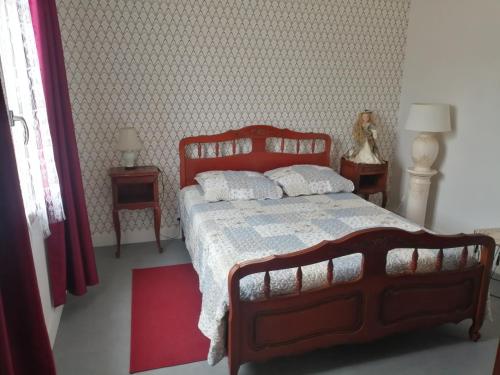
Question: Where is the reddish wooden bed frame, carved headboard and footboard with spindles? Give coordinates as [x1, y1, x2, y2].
[179, 125, 495, 375]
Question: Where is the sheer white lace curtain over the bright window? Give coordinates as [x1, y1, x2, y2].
[0, 0, 64, 236]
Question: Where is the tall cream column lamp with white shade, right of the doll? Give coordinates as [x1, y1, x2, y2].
[406, 103, 451, 226]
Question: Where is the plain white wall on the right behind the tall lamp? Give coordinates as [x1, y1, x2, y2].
[392, 0, 500, 232]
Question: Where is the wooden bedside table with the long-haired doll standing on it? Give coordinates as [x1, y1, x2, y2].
[340, 158, 388, 207]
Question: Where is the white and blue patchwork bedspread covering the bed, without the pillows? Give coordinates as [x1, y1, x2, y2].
[179, 186, 473, 365]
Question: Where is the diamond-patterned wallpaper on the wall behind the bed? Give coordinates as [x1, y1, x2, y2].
[57, 0, 410, 244]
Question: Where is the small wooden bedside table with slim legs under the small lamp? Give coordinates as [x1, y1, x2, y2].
[109, 166, 163, 258]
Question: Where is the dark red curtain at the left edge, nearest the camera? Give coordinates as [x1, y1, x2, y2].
[0, 81, 55, 375]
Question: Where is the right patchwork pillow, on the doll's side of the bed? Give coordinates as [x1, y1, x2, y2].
[264, 164, 354, 197]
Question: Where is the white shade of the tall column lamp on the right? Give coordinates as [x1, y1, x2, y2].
[406, 103, 451, 133]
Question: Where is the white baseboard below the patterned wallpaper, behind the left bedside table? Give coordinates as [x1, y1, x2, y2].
[92, 225, 181, 247]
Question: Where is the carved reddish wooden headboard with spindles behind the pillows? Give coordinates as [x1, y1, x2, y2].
[179, 125, 332, 188]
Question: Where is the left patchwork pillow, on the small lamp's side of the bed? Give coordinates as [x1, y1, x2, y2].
[195, 171, 283, 202]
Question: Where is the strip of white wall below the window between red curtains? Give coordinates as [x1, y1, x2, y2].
[29, 221, 63, 346]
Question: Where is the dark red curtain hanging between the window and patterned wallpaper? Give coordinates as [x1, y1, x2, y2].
[29, 0, 99, 306]
